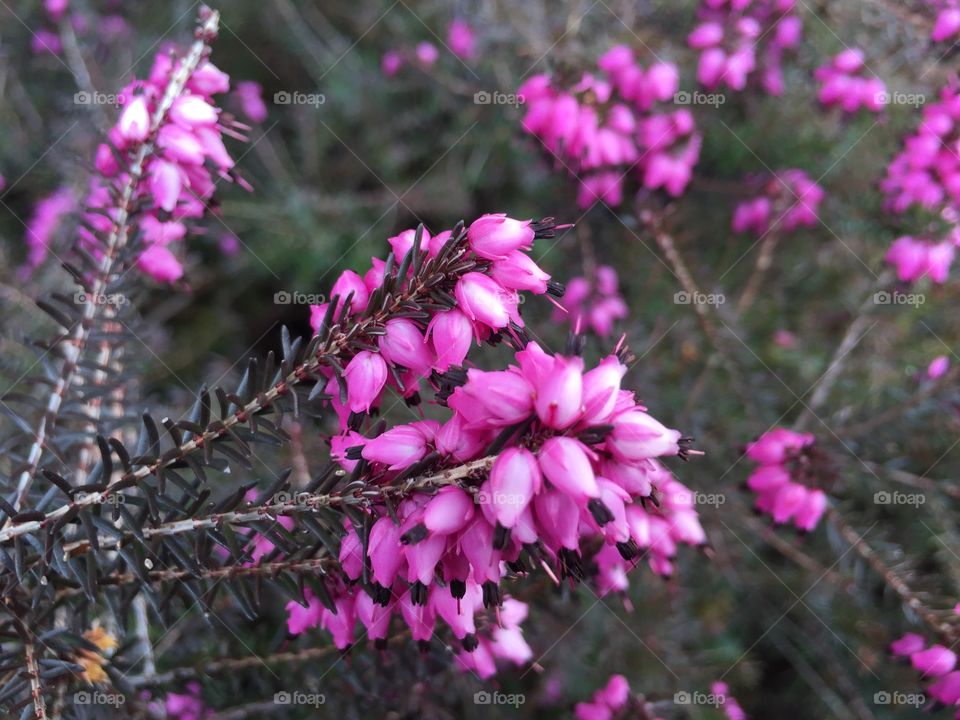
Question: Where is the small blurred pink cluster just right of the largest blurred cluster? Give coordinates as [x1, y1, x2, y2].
[731, 169, 826, 236]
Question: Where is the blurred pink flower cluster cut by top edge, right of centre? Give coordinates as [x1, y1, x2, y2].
[687, 0, 803, 95]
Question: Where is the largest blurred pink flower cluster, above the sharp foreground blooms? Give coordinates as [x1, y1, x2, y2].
[517, 45, 701, 208]
